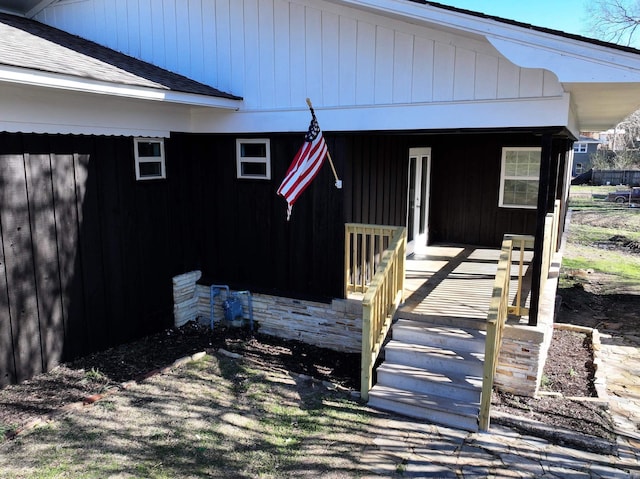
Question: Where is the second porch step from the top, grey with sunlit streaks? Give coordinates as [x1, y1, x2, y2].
[384, 339, 484, 377]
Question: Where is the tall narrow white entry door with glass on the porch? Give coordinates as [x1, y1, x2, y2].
[407, 148, 431, 255]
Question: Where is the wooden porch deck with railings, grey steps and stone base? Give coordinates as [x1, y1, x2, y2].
[345, 205, 559, 430]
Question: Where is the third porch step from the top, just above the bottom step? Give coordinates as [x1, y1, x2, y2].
[377, 362, 482, 403]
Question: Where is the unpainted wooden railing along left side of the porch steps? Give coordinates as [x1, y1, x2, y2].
[345, 223, 407, 401]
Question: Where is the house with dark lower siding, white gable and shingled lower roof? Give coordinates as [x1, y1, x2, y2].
[0, 0, 640, 390]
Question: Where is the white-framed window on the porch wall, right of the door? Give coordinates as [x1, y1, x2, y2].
[499, 147, 542, 208]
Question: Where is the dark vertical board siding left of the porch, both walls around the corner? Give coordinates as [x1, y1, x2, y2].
[0, 133, 344, 384]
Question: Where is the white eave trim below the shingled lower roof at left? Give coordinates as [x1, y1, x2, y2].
[0, 66, 242, 110]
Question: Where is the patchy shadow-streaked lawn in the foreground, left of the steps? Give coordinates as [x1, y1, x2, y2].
[0, 356, 371, 479]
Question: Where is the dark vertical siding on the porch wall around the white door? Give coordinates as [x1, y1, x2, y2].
[338, 131, 566, 247]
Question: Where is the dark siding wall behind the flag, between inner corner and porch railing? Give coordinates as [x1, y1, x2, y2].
[167, 134, 344, 300]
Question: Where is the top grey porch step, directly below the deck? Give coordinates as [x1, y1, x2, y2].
[393, 319, 487, 353]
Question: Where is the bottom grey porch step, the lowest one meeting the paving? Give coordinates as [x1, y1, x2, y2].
[369, 384, 480, 432]
